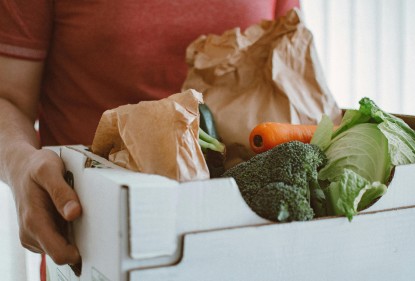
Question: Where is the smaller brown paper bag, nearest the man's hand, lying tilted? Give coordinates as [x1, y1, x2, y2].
[91, 90, 209, 182]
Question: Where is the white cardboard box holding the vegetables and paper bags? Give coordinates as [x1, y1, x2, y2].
[47, 146, 415, 281]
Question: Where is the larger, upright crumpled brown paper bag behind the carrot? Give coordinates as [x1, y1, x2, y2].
[183, 9, 341, 167]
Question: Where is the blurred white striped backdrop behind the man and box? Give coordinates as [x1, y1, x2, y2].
[0, 0, 415, 281]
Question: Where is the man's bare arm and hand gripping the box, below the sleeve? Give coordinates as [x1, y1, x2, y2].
[0, 55, 81, 264]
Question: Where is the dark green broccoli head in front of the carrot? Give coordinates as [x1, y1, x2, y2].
[223, 141, 327, 221]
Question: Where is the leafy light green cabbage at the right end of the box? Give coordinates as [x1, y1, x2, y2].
[311, 98, 415, 220]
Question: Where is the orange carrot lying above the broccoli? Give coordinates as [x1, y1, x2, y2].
[249, 122, 317, 153]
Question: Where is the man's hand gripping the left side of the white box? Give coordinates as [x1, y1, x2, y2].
[12, 149, 81, 265]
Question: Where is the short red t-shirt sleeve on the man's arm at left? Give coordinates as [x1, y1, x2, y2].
[0, 0, 53, 60]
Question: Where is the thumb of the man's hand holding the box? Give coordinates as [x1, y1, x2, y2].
[32, 151, 82, 221]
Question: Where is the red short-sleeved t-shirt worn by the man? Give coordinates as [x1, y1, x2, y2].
[0, 0, 299, 145]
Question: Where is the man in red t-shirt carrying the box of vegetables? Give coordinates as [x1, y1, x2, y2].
[0, 0, 299, 276]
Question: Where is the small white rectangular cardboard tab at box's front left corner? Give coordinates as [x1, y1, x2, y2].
[128, 174, 179, 259]
